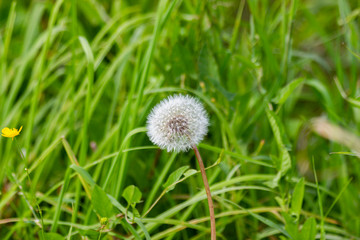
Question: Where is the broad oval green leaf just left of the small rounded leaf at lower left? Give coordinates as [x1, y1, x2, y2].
[91, 185, 114, 218]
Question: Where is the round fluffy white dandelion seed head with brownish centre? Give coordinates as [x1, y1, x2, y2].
[147, 95, 209, 152]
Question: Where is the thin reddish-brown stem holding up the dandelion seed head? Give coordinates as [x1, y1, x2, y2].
[193, 145, 216, 240]
